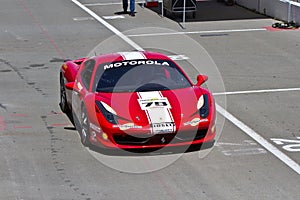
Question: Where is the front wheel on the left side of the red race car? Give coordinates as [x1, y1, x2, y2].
[80, 106, 90, 147]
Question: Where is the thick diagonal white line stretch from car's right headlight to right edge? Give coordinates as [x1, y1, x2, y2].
[216, 104, 300, 174]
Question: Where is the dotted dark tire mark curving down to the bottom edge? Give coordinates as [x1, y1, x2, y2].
[41, 116, 91, 200]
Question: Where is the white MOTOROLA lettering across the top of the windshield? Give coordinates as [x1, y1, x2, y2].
[103, 60, 169, 70]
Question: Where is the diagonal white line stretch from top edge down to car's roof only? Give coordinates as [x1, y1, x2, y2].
[71, 0, 143, 51]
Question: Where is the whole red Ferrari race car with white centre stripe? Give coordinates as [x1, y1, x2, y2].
[60, 51, 216, 149]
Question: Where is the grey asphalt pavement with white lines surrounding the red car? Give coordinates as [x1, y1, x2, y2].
[0, 0, 300, 200]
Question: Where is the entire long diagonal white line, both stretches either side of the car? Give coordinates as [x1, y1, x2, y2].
[71, 0, 300, 174]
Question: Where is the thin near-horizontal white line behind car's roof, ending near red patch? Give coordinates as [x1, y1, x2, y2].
[127, 28, 267, 37]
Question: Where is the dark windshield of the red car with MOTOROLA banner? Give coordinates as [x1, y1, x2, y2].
[94, 60, 191, 92]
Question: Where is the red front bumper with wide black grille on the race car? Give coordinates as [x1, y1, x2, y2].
[91, 122, 216, 149]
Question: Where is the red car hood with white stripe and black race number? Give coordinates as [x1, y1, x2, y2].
[96, 87, 202, 126]
